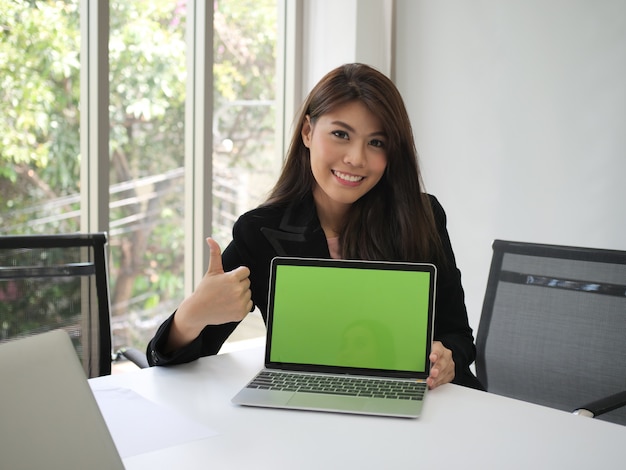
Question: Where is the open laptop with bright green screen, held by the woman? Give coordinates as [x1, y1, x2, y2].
[232, 257, 436, 418]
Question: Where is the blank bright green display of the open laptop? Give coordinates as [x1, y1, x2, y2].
[270, 265, 431, 372]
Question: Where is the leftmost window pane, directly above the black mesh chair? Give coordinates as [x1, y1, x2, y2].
[0, 0, 80, 234]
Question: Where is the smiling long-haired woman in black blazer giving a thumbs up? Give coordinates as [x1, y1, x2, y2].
[148, 64, 481, 388]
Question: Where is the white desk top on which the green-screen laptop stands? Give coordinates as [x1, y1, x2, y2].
[90, 347, 626, 470]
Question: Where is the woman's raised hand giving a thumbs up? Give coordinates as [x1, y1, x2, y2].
[168, 238, 253, 350]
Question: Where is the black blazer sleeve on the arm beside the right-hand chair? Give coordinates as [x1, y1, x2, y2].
[430, 196, 482, 389]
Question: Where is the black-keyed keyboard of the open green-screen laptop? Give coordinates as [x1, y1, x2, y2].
[248, 371, 426, 400]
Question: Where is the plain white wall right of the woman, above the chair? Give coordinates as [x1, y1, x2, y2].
[394, 0, 626, 329]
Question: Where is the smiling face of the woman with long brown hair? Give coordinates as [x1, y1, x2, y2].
[302, 101, 388, 212]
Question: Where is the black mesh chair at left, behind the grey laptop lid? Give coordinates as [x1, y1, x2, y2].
[0, 233, 112, 377]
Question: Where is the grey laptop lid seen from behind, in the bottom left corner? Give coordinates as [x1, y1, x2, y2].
[0, 330, 124, 470]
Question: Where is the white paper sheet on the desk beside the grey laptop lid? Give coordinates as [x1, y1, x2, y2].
[93, 388, 218, 458]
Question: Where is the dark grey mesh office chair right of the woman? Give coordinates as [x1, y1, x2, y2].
[476, 240, 626, 425]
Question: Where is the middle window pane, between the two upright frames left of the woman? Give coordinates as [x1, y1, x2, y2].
[108, 0, 188, 349]
